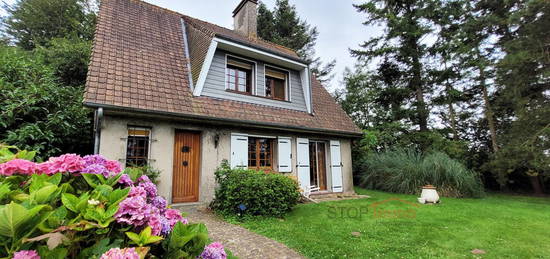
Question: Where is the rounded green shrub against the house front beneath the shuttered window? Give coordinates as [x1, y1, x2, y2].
[211, 161, 300, 217]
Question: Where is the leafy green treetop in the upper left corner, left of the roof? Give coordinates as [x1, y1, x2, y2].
[4, 0, 96, 50]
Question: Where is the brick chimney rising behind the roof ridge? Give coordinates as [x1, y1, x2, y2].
[233, 0, 258, 38]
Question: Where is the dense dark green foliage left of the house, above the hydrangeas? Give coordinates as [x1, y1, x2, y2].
[0, 47, 91, 157]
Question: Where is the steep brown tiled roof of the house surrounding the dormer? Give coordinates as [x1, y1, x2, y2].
[84, 0, 360, 135]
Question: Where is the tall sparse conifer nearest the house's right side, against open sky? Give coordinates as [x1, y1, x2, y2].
[351, 0, 435, 131]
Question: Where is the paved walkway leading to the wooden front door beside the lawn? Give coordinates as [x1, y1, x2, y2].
[181, 208, 305, 259]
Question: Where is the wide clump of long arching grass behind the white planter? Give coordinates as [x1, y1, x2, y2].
[358, 149, 484, 197]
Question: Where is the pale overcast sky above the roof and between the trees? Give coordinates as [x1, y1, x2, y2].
[146, 0, 376, 89]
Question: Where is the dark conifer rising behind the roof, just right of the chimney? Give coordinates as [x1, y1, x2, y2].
[258, 0, 336, 83]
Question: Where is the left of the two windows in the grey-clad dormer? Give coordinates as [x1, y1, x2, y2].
[225, 56, 254, 94]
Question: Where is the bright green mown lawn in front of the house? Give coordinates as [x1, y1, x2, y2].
[235, 189, 550, 258]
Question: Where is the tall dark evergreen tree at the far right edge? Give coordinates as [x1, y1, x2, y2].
[479, 0, 550, 194]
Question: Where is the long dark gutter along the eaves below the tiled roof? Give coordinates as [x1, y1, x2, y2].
[84, 102, 363, 138]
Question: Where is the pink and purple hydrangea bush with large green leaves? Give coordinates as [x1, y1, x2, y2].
[0, 145, 228, 259]
